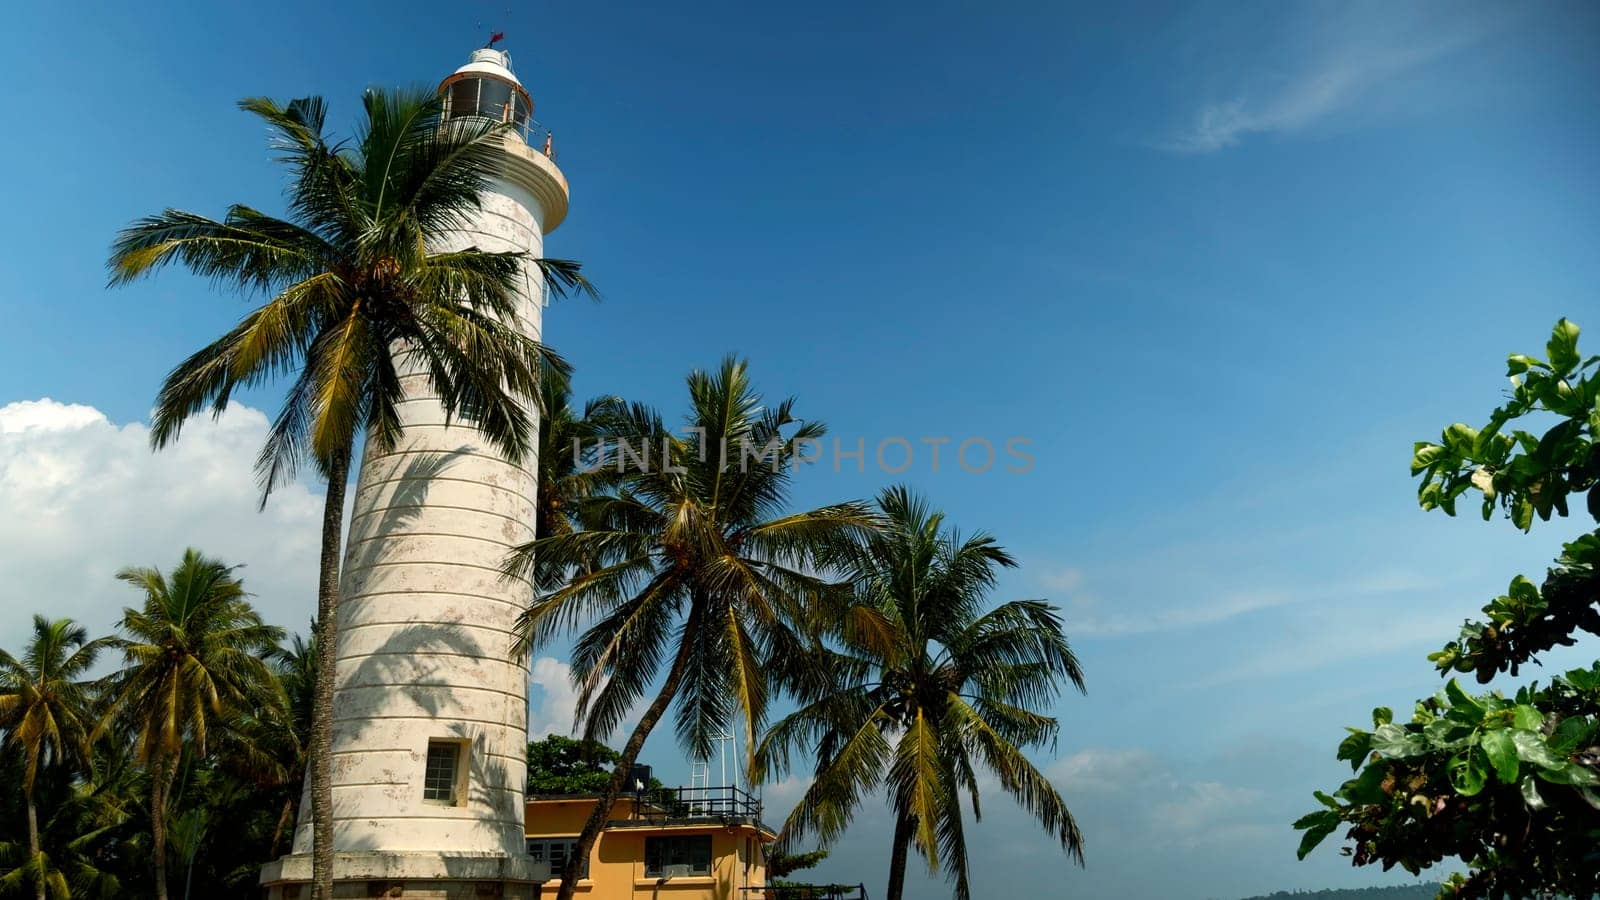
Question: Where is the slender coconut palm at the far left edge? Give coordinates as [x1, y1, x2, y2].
[0, 615, 106, 900]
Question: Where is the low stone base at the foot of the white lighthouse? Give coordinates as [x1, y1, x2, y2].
[261, 852, 550, 900]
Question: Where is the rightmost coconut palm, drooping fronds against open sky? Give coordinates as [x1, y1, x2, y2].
[757, 487, 1083, 900]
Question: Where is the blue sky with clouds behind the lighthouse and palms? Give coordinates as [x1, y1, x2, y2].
[0, 3, 1600, 900]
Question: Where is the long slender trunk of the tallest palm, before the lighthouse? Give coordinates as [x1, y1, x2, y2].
[309, 448, 350, 900]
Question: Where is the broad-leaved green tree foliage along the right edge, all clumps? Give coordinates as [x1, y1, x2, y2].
[1294, 319, 1600, 900]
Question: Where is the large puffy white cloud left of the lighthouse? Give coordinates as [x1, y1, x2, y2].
[0, 399, 322, 649]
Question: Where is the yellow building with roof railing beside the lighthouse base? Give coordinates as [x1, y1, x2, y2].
[523, 788, 778, 900]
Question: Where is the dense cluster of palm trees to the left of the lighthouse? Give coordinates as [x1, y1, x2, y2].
[0, 549, 315, 900]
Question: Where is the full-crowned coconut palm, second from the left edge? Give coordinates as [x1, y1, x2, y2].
[106, 548, 283, 900]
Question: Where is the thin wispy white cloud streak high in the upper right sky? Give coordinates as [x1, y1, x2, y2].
[1162, 5, 1499, 154]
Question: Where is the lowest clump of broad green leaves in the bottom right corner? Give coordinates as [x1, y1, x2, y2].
[1294, 663, 1600, 897]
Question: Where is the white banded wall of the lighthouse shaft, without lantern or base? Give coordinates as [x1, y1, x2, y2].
[294, 173, 544, 857]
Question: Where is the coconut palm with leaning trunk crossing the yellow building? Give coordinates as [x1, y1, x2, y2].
[507, 357, 874, 900]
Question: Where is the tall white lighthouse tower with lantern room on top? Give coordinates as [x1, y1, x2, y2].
[261, 50, 568, 900]
